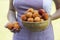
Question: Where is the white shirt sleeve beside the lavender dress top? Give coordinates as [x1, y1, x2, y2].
[43, 0, 52, 14]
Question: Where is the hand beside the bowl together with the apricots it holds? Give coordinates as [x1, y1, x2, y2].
[6, 22, 21, 32]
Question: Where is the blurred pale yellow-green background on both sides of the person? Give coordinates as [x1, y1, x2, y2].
[0, 0, 60, 40]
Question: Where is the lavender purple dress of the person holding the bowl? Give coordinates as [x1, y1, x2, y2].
[13, 0, 54, 40]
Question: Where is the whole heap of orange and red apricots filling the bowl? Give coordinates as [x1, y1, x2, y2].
[21, 8, 48, 22]
